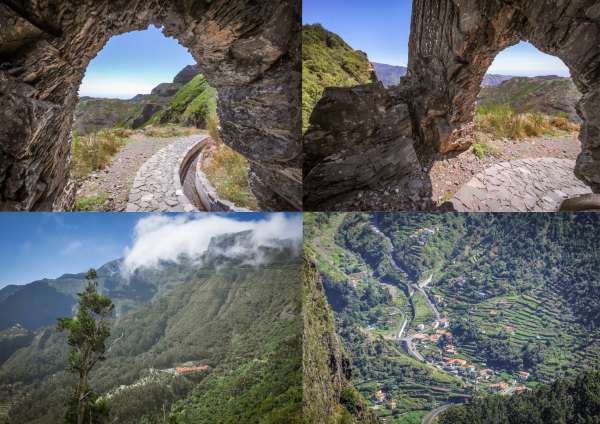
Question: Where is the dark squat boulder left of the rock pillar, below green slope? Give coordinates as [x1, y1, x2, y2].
[303, 83, 431, 210]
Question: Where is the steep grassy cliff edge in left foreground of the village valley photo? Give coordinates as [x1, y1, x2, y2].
[303, 255, 378, 424]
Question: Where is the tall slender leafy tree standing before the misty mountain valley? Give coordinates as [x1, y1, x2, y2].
[57, 269, 114, 424]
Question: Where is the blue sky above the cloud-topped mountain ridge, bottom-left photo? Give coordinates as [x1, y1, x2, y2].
[0, 212, 301, 288]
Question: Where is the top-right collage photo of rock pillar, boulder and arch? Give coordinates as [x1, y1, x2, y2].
[302, 0, 600, 212]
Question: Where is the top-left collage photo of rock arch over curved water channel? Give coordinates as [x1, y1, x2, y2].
[0, 0, 302, 212]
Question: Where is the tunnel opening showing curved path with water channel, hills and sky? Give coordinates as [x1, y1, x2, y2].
[71, 26, 257, 211]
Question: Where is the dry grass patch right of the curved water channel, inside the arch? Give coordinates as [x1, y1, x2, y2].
[204, 114, 258, 210]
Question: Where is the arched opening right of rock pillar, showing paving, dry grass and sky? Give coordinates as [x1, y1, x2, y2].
[429, 41, 591, 212]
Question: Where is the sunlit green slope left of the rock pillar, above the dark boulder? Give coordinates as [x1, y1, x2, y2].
[302, 24, 377, 129]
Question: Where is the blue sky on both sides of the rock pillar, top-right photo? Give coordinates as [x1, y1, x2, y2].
[302, 0, 569, 76]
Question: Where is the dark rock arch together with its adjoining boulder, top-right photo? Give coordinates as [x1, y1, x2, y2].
[303, 0, 600, 210]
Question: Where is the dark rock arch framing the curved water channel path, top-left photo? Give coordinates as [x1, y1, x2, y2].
[0, 0, 302, 210]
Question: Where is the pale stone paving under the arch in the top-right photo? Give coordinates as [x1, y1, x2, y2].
[451, 158, 591, 212]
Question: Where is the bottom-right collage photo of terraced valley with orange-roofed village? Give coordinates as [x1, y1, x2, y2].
[303, 212, 600, 424]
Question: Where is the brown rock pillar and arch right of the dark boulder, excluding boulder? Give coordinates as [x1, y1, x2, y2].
[406, 0, 600, 192]
